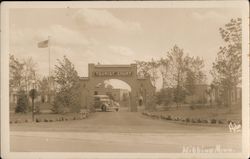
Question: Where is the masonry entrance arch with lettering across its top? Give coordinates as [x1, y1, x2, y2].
[80, 64, 155, 112]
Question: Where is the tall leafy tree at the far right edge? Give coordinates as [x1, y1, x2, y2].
[211, 18, 242, 107]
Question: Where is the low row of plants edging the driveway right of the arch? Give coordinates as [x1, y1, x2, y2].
[142, 112, 241, 124]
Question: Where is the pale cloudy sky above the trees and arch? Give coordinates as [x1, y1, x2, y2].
[9, 8, 240, 87]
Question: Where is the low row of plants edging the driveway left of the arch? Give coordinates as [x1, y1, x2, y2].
[10, 112, 90, 124]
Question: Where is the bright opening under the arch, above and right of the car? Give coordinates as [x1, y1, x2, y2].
[94, 79, 131, 111]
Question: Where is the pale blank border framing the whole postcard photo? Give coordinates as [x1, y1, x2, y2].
[1, 1, 249, 159]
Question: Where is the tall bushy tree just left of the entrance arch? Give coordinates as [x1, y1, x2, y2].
[52, 56, 81, 113]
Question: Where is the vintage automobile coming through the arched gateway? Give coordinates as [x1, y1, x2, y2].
[94, 95, 119, 112]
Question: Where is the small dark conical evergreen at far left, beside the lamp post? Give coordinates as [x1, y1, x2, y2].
[15, 90, 28, 113]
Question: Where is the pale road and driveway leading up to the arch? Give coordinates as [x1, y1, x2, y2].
[10, 108, 241, 152]
